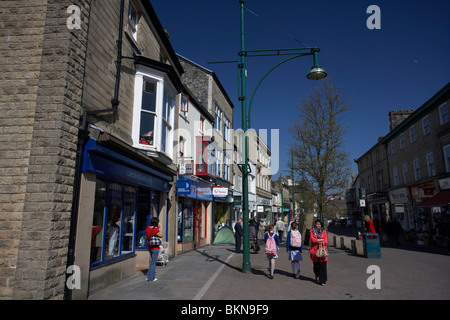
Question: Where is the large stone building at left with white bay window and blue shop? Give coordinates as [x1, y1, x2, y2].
[0, 0, 213, 299]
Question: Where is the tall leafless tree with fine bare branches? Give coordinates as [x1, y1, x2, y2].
[288, 80, 350, 218]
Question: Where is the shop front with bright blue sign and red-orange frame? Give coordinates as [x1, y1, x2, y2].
[176, 175, 213, 253]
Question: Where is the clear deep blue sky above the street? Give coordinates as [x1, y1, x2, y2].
[151, 0, 450, 182]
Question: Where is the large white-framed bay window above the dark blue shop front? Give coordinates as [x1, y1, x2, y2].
[132, 68, 177, 158]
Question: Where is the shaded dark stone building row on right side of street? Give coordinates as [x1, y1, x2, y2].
[355, 84, 450, 244]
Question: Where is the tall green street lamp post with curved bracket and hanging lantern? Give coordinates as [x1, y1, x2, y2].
[238, 0, 327, 273]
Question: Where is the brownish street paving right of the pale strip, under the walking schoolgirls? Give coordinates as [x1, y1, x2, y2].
[203, 242, 450, 300]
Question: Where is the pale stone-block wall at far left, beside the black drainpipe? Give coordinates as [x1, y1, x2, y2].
[0, 0, 89, 299]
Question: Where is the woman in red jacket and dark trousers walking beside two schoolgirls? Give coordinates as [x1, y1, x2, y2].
[309, 220, 328, 286]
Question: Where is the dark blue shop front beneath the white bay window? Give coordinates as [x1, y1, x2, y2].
[75, 139, 172, 295]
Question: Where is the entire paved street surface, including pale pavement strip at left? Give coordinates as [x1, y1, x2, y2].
[89, 232, 450, 302]
